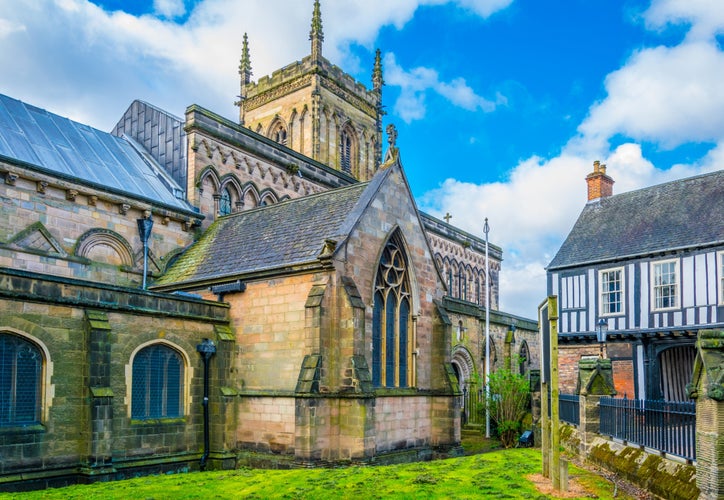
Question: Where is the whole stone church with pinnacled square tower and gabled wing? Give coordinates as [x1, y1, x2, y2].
[0, 1, 539, 490]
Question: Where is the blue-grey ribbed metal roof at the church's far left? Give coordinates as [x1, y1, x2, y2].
[0, 94, 191, 211]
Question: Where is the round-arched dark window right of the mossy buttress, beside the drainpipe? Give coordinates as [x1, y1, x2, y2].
[131, 344, 184, 419]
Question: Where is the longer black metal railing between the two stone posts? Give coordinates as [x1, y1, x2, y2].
[600, 397, 696, 461]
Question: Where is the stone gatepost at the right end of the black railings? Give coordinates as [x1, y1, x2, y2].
[689, 330, 724, 500]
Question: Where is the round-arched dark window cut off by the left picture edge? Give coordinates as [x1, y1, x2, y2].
[0, 333, 43, 427]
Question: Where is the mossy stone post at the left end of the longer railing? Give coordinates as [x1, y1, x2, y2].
[577, 356, 616, 456]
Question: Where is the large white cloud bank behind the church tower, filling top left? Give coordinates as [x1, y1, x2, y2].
[0, 0, 510, 130]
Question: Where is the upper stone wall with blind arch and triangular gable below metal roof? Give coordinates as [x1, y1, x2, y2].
[0, 165, 194, 285]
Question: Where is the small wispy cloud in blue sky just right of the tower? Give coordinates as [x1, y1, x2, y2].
[384, 52, 506, 123]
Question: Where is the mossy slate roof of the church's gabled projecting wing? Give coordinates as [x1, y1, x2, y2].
[154, 173, 378, 289]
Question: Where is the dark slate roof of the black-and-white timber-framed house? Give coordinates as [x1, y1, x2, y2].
[547, 170, 724, 271]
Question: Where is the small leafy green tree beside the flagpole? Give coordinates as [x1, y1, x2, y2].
[486, 362, 530, 448]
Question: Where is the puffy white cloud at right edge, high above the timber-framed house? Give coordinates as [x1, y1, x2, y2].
[579, 42, 724, 148]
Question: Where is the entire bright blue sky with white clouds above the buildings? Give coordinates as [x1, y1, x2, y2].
[0, 0, 724, 317]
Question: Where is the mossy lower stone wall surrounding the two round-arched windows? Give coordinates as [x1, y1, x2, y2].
[0, 269, 228, 489]
